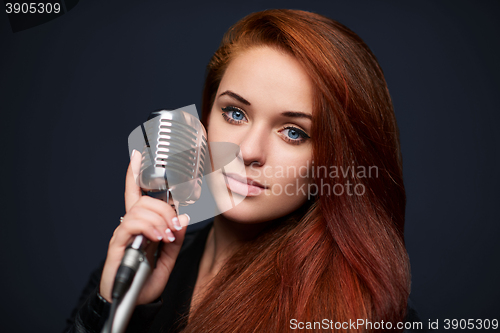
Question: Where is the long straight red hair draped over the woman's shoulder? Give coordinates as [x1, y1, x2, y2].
[184, 10, 410, 333]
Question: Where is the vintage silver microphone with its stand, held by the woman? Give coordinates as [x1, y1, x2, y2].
[102, 105, 209, 333]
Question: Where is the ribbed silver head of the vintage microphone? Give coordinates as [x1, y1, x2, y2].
[138, 106, 208, 206]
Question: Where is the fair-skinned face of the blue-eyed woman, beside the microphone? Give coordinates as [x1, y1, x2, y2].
[208, 47, 313, 223]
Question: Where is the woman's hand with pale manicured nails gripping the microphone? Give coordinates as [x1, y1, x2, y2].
[99, 150, 189, 304]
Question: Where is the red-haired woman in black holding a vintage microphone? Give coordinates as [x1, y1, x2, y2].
[68, 10, 416, 332]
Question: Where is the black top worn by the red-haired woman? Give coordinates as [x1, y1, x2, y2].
[64, 221, 425, 333]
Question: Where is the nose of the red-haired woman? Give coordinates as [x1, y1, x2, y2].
[240, 124, 269, 166]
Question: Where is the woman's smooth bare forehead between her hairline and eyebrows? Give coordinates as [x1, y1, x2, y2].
[218, 47, 313, 113]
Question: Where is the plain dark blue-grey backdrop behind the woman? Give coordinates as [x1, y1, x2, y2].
[0, 0, 500, 332]
